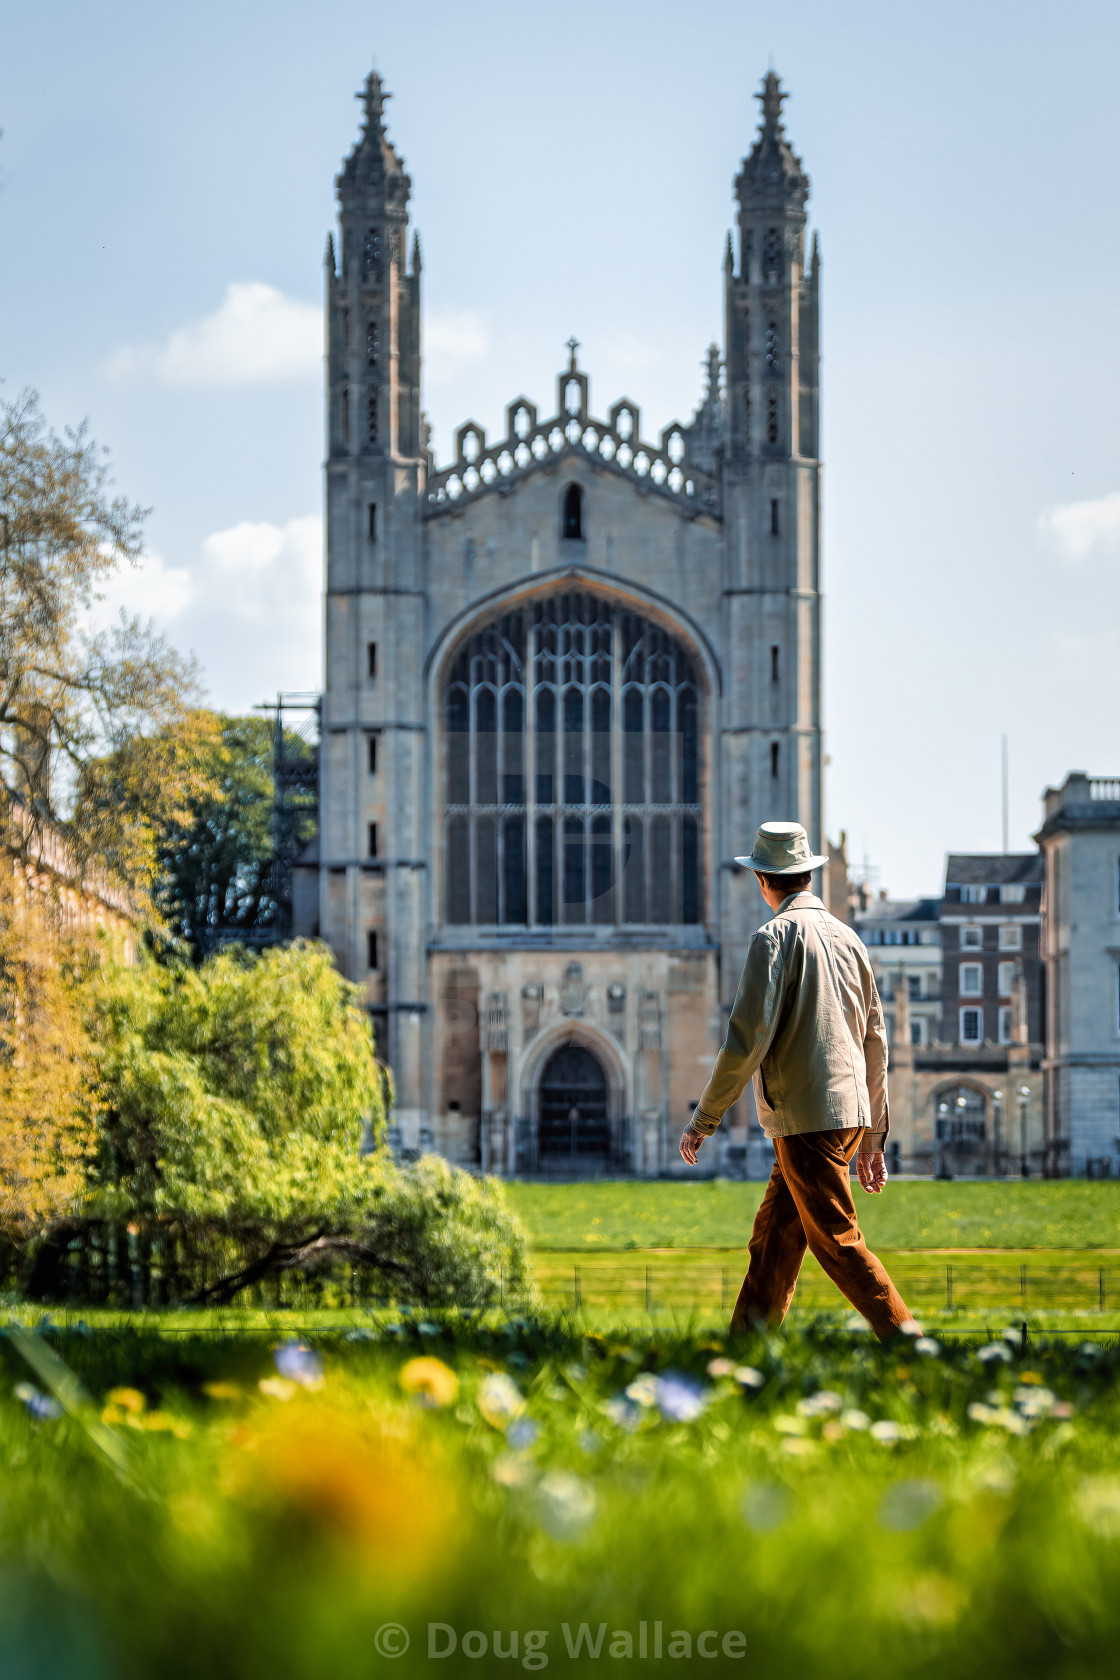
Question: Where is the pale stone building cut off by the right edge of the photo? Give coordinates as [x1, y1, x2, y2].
[1036, 771, 1120, 1176]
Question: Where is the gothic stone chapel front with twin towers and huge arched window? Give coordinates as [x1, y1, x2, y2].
[317, 74, 821, 1174]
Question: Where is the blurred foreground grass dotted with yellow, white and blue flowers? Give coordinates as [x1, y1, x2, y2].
[0, 1310, 1120, 1680]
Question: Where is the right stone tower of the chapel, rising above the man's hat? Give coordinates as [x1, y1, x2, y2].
[724, 71, 824, 974]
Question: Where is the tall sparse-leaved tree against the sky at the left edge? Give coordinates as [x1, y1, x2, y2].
[0, 393, 196, 895]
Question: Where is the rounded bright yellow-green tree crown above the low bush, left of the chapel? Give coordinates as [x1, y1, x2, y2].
[92, 946, 385, 1242]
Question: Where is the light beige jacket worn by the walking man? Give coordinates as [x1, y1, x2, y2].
[692, 892, 890, 1154]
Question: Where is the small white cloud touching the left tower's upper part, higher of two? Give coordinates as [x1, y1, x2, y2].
[106, 281, 322, 385]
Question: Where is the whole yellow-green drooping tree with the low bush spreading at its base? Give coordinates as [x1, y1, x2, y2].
[29, 944, 531, 1307]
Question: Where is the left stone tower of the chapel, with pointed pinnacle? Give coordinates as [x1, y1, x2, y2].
[319, 72, 427, 1142]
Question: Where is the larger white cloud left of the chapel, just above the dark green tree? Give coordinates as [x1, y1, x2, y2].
[96, 514, 322, 711]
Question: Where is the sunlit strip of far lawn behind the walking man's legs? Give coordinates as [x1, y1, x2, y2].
[507, 1179, 1120, 1250]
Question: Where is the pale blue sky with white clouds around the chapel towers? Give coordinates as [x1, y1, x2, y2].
[0, 0, 1120, 894]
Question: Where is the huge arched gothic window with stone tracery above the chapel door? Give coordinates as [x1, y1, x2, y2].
[443, 593, 702, 927]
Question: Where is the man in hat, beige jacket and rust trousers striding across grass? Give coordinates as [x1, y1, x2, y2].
[680, 823, 910, 1342]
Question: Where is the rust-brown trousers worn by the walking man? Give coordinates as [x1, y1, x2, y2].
[730, 1126, 910, 1342]
